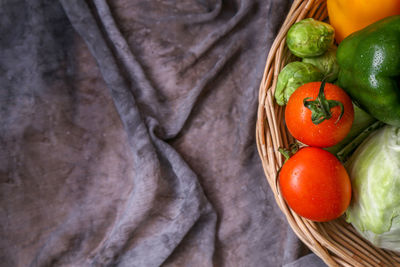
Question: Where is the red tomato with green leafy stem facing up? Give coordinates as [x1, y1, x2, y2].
[285, 82, 354, 147]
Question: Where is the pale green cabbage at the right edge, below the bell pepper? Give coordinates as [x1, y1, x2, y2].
[346, 125, 400, 251]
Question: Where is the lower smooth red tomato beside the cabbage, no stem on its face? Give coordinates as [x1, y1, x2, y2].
[279, 147, 351, 222]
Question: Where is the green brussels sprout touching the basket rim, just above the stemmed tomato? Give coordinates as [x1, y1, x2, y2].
[275, 61, 324, 106]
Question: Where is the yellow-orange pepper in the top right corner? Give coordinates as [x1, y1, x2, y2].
[327, 0, 400, 43]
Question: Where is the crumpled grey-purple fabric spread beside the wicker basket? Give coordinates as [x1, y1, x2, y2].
[0, 0, 324, 266]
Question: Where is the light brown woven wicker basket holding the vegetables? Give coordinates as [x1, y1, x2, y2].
[256, 0, 400, 267]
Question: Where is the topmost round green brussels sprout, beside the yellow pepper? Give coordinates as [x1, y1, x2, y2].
[286, 18, 335, 58]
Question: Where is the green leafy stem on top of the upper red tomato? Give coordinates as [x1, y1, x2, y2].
[303, 80, 344, 125]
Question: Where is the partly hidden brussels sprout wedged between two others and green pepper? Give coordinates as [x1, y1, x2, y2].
[303, 45, 339, 82]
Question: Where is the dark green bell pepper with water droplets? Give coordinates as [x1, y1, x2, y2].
[337, 15, 400, 126]
